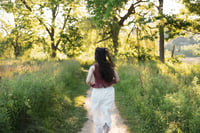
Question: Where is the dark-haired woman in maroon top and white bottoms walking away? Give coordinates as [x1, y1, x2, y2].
[86, 47, 119, 133]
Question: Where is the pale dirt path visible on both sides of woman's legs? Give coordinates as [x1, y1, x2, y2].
[79, 89, 129, 133]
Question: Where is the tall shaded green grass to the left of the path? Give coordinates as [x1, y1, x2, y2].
[0, 60, 87, 133]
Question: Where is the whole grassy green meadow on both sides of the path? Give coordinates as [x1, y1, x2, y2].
[0, 57, 200, 133]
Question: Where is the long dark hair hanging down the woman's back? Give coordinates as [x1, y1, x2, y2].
[95, 47, 115, 82]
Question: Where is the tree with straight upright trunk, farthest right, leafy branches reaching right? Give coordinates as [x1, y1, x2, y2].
[140, 0, 191, 63]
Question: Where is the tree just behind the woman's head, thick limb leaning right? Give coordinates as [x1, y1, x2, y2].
[87, 0, 149, 54]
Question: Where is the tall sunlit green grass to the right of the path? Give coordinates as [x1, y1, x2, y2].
[115, 62, 200, 133]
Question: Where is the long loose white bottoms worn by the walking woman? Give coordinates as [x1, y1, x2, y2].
[91, 86, 115, 128]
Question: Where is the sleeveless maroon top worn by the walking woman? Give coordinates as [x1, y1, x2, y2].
[91, 64, 116, 88]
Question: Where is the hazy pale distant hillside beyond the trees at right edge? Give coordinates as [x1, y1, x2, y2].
[165, 35, 200, 57]
